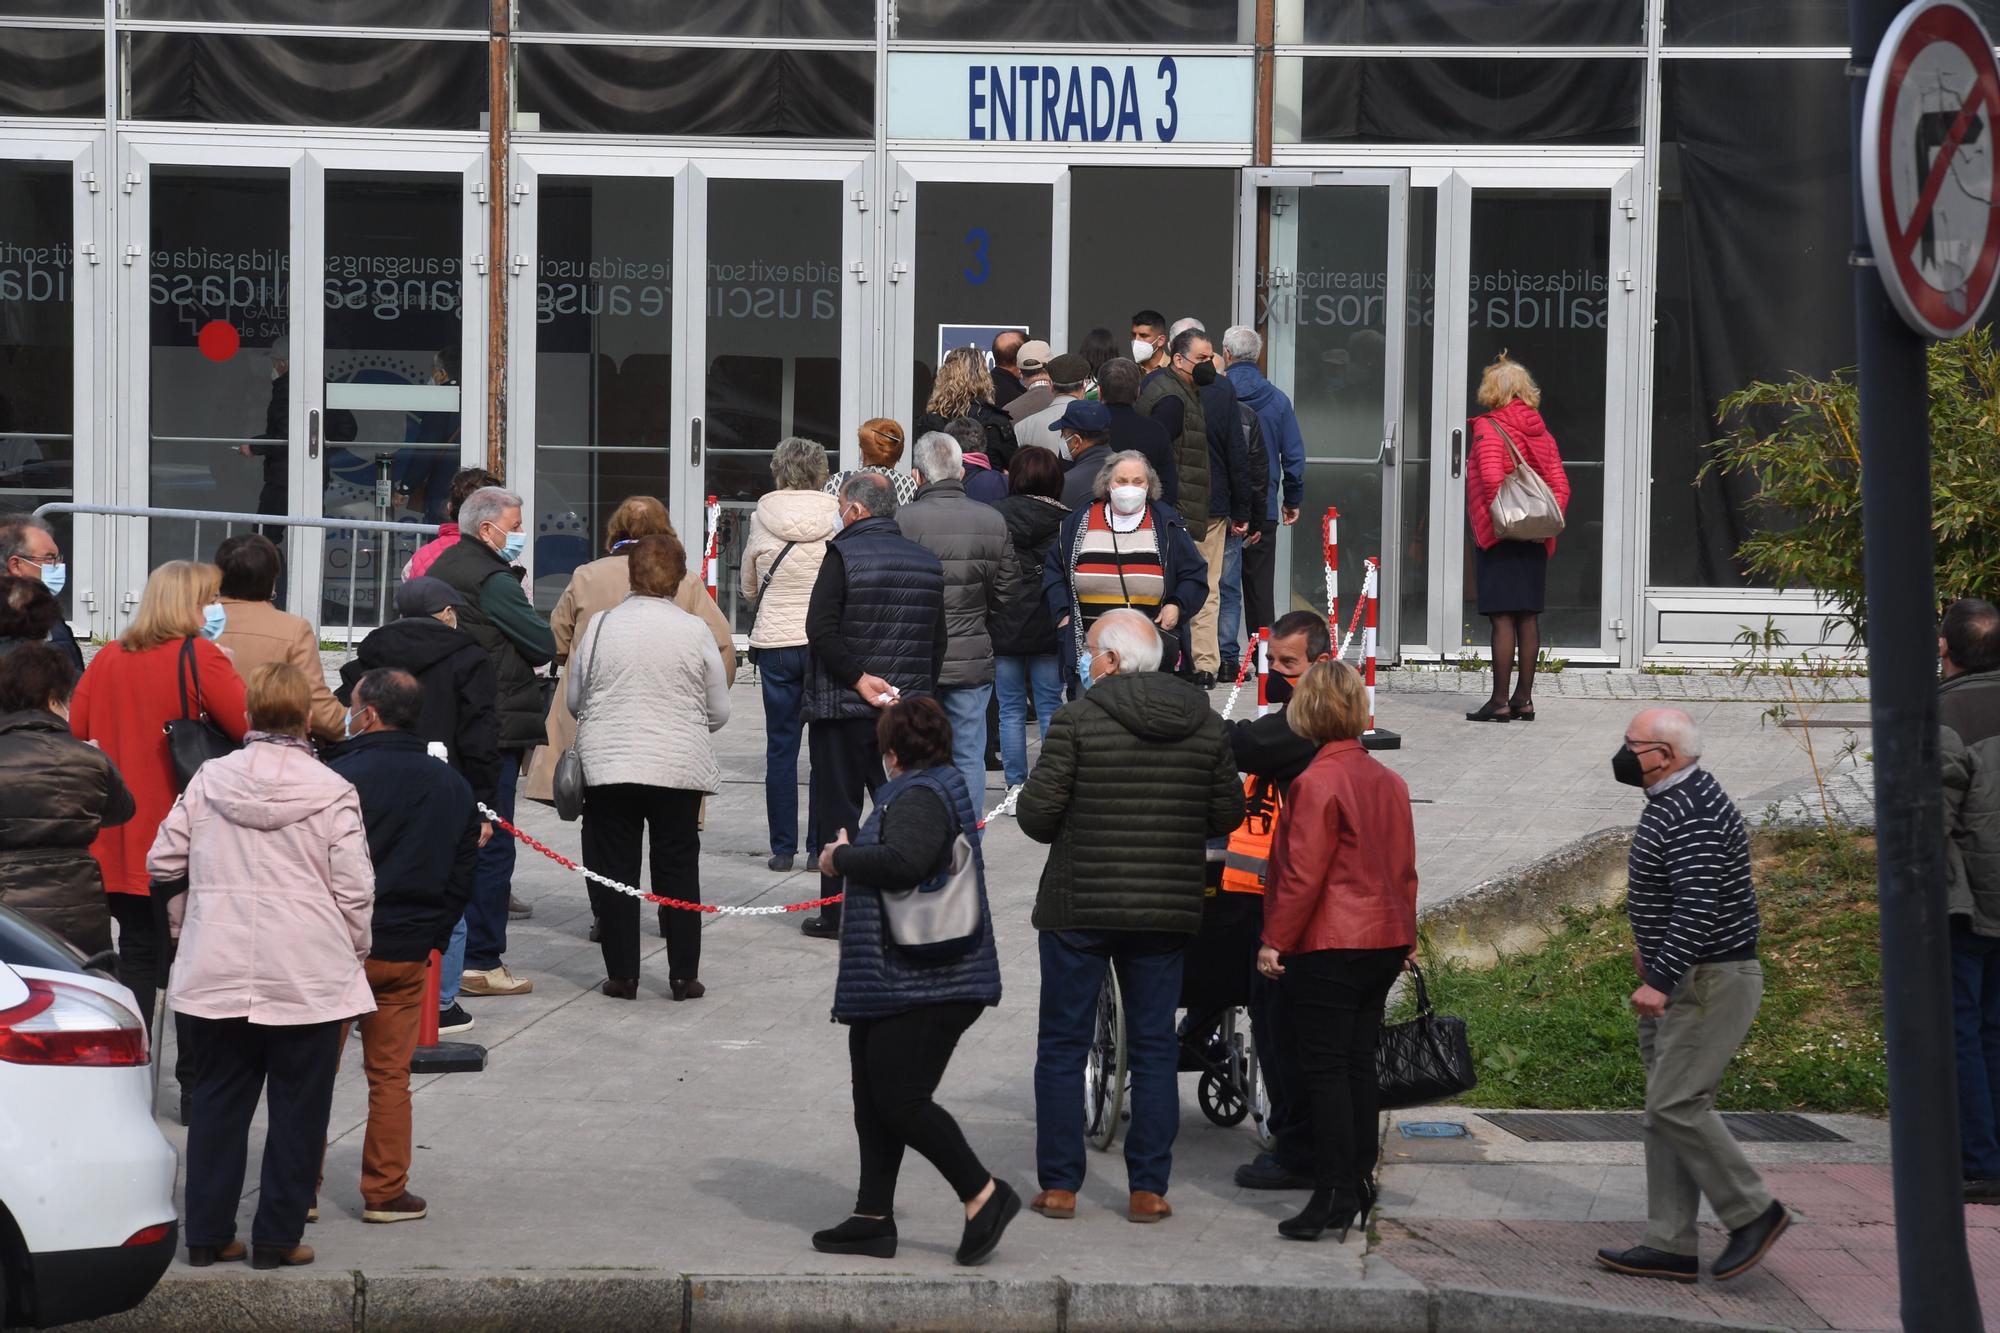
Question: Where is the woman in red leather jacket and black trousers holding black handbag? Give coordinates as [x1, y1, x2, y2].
[1256, 662, 1416, 1241]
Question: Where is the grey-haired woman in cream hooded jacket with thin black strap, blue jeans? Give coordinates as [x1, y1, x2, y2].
[742, 436, 840, 871]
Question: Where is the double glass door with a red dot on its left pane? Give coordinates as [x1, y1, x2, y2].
[120, 140, 486, 634]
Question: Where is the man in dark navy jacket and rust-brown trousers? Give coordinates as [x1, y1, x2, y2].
[332, 671, 480, 1223]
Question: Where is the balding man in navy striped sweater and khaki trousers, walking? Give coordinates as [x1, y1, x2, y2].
[1598, 709, 1790, 1283]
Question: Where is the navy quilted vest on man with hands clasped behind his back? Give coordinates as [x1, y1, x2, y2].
[804, 518, 944, 723]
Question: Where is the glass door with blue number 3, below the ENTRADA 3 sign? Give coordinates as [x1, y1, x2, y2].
[888, 162, 1070, 426]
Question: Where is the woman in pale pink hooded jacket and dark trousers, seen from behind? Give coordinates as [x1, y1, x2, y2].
[146, 662, 374, 1269]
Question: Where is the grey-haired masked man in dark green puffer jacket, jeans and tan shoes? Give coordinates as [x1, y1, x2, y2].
[428, 486, 556, 995]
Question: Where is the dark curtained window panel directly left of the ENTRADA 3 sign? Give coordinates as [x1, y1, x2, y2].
[516, 44, 874, 138]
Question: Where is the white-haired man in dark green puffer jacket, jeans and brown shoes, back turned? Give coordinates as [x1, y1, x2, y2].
[1014, 608, 1244, 1223]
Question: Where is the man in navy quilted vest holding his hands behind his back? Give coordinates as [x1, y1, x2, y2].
[800, 472, 948, 939]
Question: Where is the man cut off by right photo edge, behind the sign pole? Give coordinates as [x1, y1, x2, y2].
[1938, 598, 2000, 1203]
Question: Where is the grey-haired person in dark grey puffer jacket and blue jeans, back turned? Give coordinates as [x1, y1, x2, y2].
[900, 430, 1008, 827]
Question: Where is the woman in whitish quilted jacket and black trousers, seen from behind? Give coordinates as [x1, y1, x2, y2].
[568, 536, 730, 1001]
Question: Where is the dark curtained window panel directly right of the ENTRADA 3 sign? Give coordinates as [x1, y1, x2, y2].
[1302, 56, 1646, 144]
